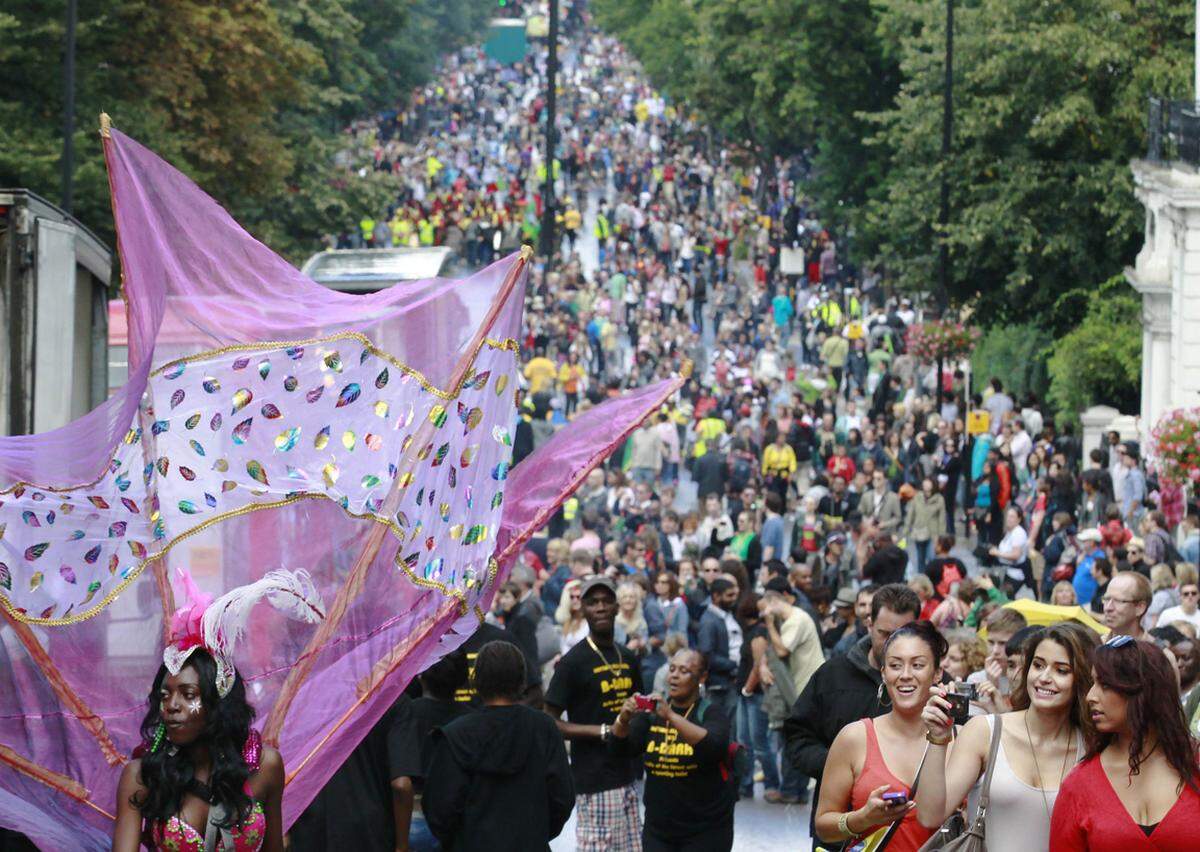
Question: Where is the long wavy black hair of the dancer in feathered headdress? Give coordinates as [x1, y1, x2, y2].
[130, 650, 254, 828]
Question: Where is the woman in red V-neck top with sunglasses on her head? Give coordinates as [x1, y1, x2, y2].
[1050, 636, 1200, 852]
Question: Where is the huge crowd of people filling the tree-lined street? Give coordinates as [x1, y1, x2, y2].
[296, 1, 1200, 852]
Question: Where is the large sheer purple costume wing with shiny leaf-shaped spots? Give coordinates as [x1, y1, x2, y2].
[0, 118, 682, 850]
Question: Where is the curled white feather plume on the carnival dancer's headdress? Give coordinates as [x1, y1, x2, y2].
[204, 570, 325, 659]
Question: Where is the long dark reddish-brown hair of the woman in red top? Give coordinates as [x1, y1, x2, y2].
[1087, 641, 1200, 792]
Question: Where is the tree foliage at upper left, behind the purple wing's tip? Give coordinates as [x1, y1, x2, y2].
[0, 0, 492, 260]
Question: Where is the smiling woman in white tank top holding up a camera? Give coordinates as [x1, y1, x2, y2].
[917, 622, 1098, 852]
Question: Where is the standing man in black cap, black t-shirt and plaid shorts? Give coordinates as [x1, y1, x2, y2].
[546, 576, 642, 852]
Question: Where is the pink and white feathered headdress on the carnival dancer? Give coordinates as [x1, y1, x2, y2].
[162, 569, 325, 698]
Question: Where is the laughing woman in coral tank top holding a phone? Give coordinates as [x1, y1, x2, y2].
[815, 622, 947, 852]
